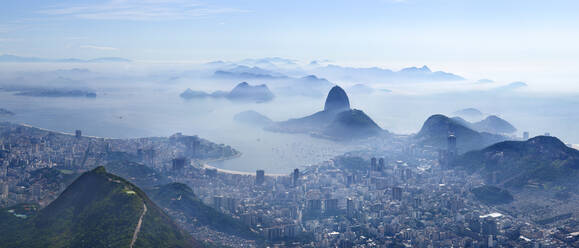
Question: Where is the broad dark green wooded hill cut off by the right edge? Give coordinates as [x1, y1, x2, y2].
[454, 136, 579, 187]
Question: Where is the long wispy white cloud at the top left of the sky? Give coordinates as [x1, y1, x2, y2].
[38, 0, 247, 21]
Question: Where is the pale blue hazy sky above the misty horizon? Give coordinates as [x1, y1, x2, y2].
[0, 0, 579, 82]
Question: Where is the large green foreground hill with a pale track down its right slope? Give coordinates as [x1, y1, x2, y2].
[0, 167, 200, 247]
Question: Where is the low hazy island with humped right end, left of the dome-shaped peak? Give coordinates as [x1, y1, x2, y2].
[179, 82, 274, 103]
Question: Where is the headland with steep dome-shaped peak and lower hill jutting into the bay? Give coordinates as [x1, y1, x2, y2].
[265, 86, 387, 140]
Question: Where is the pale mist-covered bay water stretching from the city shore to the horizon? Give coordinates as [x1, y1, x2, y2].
[0, 58, 579, 173]
